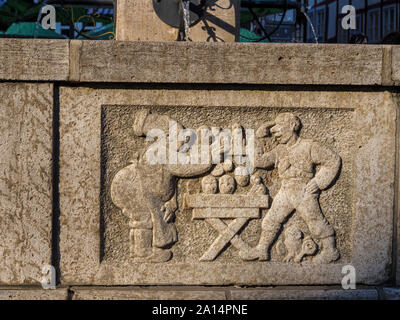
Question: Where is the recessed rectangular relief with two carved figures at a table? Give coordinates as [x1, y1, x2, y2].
[101, 105, 354, 264]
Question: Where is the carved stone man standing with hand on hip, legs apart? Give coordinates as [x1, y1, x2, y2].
[239, 113, 341, 263]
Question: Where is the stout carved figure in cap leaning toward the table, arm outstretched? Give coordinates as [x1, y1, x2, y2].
[111, 110, 217, 262]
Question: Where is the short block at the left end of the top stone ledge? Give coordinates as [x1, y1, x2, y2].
[0, 39, 69, 81]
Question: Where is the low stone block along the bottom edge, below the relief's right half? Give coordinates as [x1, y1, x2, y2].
[231, 287, 379, 300]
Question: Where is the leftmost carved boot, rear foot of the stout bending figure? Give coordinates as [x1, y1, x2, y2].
[134, 229, 153, 262]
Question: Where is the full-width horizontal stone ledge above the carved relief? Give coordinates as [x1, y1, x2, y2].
[0, 39, 400, 86]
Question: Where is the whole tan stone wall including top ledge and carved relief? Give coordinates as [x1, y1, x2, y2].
[0, 39, 400, 299]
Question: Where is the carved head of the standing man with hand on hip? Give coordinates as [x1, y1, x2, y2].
[271, 112, 301, 144]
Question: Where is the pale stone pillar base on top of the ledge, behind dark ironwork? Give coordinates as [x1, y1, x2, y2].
[116, 0, 239, 42]
